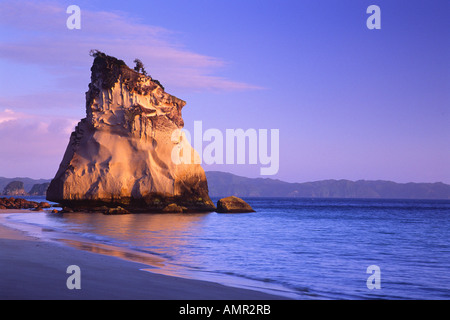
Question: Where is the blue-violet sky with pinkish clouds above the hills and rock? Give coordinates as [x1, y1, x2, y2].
[0, 0, 450, 183]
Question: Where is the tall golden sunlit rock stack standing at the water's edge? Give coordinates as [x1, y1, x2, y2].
[47, 52, 215, 212]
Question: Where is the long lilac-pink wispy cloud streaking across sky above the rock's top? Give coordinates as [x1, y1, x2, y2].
[0, 1, 259, 90]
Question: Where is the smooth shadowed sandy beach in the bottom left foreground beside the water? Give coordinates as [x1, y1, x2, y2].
[0, 210, 286, 300]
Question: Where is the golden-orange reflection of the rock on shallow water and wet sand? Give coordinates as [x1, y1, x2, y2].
[49, 213, 214, 276]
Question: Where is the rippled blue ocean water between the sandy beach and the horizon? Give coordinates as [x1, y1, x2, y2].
[1, 197, 450, 300]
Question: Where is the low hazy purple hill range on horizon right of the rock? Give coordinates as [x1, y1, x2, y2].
[206, 171, 450, 199]
